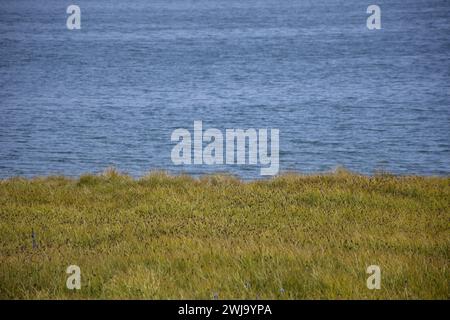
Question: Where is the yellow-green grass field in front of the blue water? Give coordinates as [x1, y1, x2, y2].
[0, 170, 450, 299]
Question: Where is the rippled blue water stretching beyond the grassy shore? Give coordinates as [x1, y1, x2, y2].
[0, 0, 450, 179]
